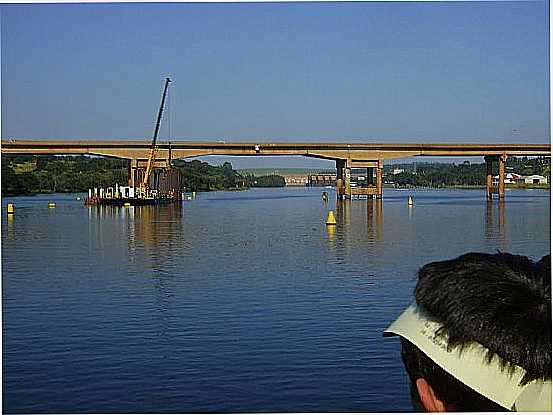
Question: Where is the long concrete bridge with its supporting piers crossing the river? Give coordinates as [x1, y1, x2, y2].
[1, 139, 551, 199]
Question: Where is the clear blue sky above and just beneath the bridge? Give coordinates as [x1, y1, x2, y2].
[0, 1, 550, 167]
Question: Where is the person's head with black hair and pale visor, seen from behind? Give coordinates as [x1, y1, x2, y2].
[387, 253, 551, 412]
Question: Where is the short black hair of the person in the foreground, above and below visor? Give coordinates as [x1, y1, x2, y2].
[402, 252, 551, 411]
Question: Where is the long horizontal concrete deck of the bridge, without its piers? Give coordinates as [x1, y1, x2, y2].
[2, 139, 551, 160]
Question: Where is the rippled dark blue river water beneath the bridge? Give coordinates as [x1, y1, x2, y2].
[2, 188, 550, 413]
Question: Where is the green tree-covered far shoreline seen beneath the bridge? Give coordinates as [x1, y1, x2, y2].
[2, 155, 551, 196]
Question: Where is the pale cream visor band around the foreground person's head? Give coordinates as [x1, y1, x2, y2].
[384, 304, 551, 412]
